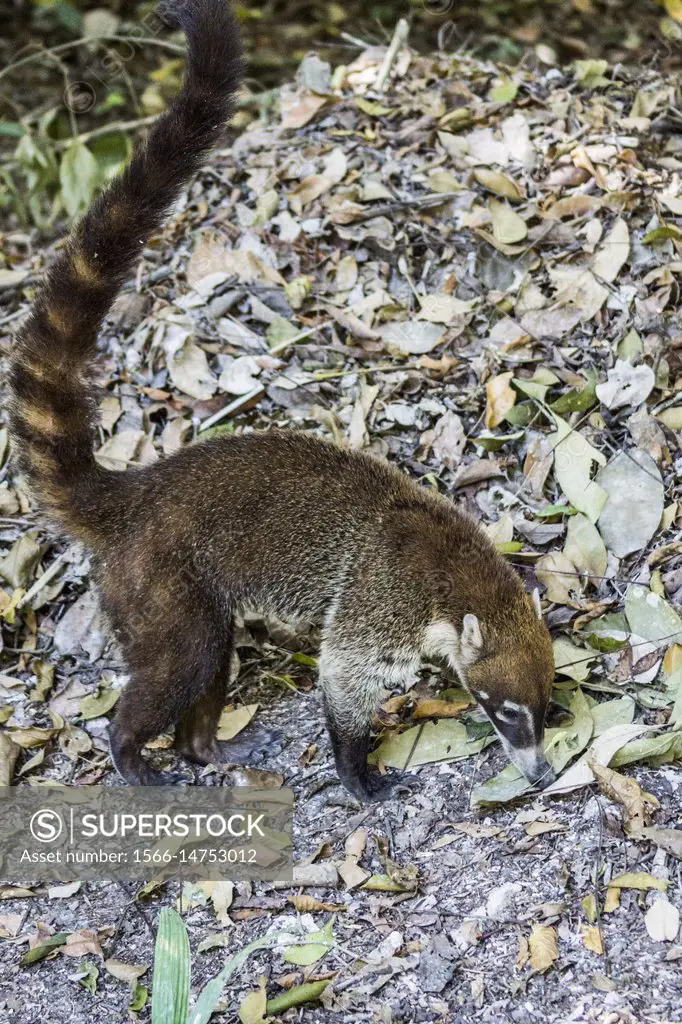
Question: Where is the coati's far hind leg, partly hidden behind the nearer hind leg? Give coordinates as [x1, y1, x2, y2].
[175, 625, 284, 765]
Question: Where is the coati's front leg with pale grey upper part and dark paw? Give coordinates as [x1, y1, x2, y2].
[319, 635, 404, 803]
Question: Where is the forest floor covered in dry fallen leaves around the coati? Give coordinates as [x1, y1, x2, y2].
[0, 19, 682, 1024]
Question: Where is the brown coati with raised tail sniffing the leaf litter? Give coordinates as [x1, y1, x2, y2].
[9, 0, 554, 800]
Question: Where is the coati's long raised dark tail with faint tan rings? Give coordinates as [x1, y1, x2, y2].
[9, 0, 242, 543]
